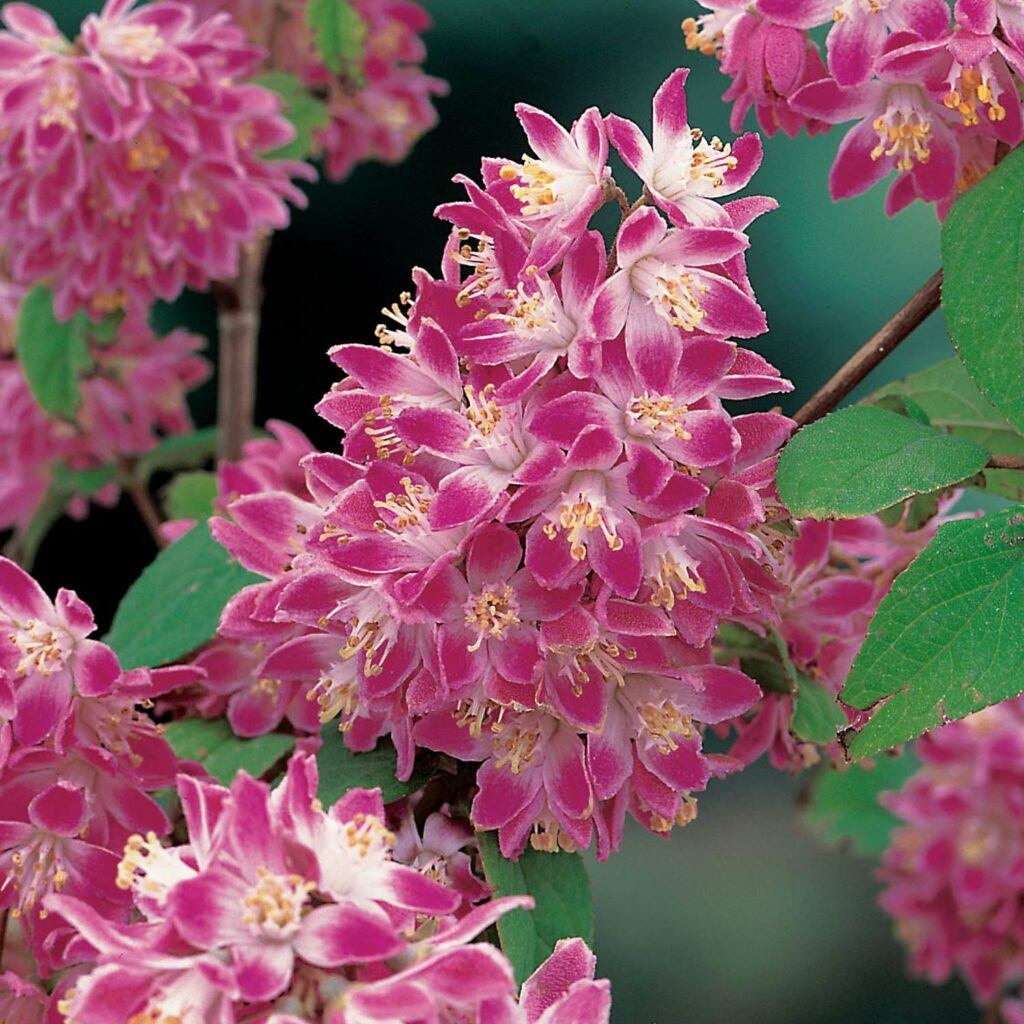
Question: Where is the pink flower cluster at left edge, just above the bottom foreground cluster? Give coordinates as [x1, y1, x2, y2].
[0, 559, 199, 970]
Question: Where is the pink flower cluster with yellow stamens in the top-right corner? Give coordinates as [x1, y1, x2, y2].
[683, 0, 1024, 216]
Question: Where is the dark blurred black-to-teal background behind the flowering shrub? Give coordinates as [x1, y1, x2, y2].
[29, 0, 978, 1024]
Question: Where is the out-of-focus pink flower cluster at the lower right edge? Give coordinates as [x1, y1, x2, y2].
[881, 700, 1024, 1020]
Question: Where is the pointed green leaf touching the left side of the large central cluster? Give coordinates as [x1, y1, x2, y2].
[105, 522, 262, 669]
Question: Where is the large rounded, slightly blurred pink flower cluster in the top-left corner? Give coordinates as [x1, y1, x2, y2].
[0, 0, 312, 318]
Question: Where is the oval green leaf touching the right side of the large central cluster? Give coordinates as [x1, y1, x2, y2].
[778, 406, 988, 519]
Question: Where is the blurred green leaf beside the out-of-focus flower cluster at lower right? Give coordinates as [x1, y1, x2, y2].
[807, 749, 918, 856]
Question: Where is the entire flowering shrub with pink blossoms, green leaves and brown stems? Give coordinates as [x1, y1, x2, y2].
[0, 0, 1024, 1024]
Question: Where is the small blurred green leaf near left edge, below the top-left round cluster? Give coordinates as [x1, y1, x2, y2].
[15, 285, 92, 420]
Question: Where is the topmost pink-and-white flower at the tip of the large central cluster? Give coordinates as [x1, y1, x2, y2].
[605, 68, 761, 227]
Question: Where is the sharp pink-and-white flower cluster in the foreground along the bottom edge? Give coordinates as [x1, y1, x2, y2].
[46, 755, 610, 1024]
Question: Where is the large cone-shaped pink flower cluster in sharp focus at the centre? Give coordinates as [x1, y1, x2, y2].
[203, 71, 792, 856]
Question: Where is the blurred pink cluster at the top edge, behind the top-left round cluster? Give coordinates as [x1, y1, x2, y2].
[194, 0, 447, 181]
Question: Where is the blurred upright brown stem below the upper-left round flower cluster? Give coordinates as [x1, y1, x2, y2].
[213, 239, 269, 461]
